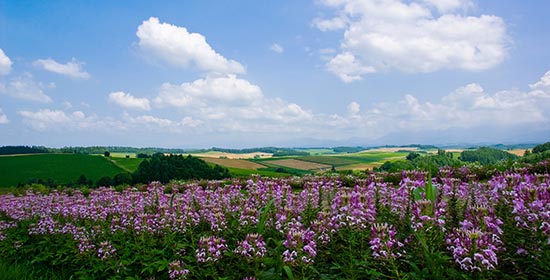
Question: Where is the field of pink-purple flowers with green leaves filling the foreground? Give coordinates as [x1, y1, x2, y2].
[0, 165, 550, 279]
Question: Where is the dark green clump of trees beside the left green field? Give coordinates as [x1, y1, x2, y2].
[132, 153, 230, 183]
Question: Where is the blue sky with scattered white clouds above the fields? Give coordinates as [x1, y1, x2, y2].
[0, 0, 550, 148]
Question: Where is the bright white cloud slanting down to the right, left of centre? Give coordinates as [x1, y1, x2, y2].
[136, 17, 245, 74]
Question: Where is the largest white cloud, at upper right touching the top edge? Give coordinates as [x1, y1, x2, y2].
[313, 0, 509, 82]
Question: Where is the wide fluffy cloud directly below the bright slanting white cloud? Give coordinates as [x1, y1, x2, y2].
[155, 75, 313, 132]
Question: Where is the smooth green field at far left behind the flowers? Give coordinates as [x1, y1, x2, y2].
[0, 154, 124, 187]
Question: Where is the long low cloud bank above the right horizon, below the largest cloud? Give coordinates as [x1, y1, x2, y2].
[333, 70, 550, 137]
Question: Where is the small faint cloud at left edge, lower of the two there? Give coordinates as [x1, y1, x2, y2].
[0, 74, 52, 103]
